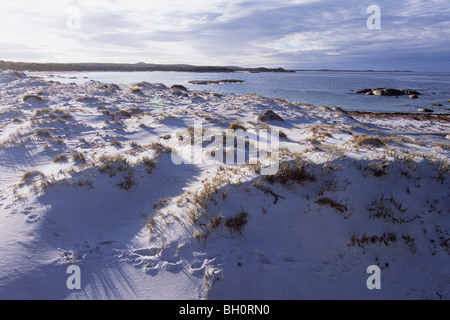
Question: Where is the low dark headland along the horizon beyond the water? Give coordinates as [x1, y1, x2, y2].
[0, 60, 295, 72]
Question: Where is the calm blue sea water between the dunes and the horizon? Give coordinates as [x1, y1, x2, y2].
[35, 71, 450, 113]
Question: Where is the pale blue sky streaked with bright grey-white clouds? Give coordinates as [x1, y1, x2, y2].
[0, 0, 450, 71]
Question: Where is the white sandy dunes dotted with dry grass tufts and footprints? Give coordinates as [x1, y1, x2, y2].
[0, 71, 450, 300]
